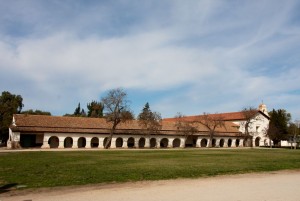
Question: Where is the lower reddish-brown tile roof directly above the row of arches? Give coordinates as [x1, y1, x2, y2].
[11, 114, 240, 136]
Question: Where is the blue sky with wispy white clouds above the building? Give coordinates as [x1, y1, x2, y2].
[0, 0, 300, 119]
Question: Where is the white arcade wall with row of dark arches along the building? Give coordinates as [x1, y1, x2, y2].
[42, 134, 244, 148]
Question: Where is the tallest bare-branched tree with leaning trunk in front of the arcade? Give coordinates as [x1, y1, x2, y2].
[101, 88, 134, 149]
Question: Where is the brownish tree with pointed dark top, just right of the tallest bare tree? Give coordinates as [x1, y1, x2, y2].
[137, 103, 162, 134]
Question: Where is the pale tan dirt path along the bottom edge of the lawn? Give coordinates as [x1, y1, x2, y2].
[0, 171, 300, 201]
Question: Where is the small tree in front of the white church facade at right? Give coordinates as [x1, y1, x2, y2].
[240, 107, 258, 147]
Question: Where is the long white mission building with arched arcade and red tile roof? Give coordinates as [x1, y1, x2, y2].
[7, 104, 269, 149]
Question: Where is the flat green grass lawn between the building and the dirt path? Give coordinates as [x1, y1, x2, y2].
[0, 149, 300, 189]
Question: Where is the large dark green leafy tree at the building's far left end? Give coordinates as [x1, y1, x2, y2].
[0, 91, 24, 142]
